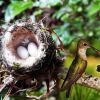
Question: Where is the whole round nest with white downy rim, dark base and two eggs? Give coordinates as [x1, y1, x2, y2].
[1, 20, 63, 95]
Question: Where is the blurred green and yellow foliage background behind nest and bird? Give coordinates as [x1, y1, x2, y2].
[0, 0, 100, 100]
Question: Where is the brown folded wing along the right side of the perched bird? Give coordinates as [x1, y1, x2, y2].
[65, 62, 87, 88]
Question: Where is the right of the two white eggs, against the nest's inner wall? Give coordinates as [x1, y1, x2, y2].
[28, 42, 38, 56]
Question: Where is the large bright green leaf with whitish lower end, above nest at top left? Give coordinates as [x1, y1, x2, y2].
[5, 0, 33, 22]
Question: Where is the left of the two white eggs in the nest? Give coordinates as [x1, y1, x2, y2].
[17, 46, 29, 59]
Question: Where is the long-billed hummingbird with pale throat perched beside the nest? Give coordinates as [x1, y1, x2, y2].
[61, 39, 96, 97]
